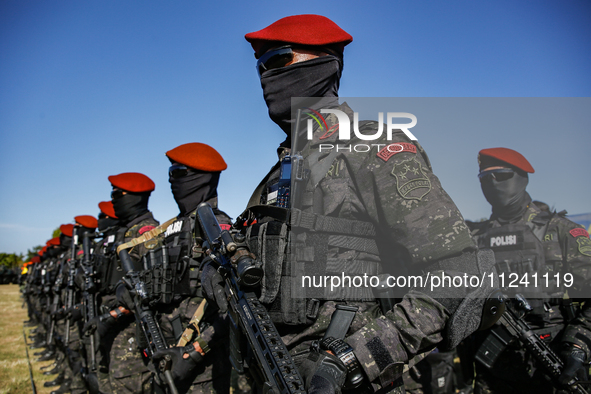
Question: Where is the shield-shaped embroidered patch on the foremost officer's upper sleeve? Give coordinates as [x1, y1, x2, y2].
[392, 158, 431, 200]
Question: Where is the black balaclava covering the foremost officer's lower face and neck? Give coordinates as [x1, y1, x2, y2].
[261, 55, 343, 136]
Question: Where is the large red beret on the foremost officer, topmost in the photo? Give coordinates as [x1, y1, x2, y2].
[244, 14, 353, 58]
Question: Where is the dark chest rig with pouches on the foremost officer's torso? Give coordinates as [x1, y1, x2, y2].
[242, 139, 381, 325]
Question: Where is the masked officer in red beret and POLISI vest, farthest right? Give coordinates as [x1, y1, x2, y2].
[470, 148, 591, 393]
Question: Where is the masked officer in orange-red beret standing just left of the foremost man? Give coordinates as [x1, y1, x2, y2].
[142, 142, 231, 393]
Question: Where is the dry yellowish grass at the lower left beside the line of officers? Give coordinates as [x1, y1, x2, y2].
[0, 285, 57, 394]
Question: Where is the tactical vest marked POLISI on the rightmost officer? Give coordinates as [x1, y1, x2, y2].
[478, 215, 564, 304]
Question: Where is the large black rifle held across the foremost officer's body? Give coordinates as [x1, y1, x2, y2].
[197, 203, 305, 394]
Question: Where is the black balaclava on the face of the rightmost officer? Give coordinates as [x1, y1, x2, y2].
[480, 169, 531, 222]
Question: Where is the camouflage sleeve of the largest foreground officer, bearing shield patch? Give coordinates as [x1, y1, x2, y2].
[337, 133, 480, 386]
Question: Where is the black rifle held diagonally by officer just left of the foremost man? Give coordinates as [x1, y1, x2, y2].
[119, 249, 178, 394]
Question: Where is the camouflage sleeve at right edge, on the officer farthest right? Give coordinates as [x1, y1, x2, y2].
[558, 219, 591, 357]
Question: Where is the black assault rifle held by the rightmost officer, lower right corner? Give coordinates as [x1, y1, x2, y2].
[475, 294, 588, 394]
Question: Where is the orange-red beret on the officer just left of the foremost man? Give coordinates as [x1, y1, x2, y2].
[166, 142, 228, 172]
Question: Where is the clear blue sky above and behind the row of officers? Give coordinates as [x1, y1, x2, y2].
[0, 0, 591, 253]
